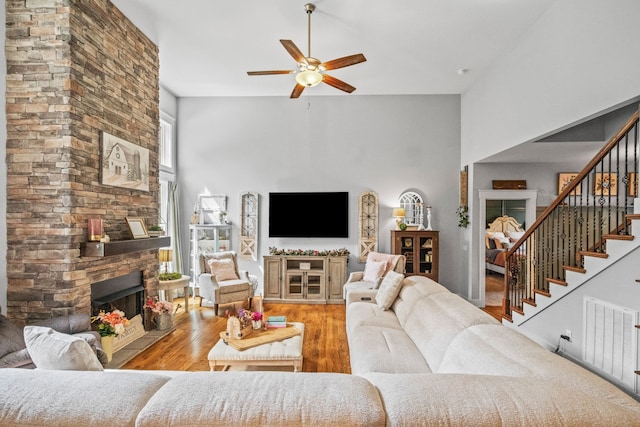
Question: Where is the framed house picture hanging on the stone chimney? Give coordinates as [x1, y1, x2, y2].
[100, 132, 149, 191]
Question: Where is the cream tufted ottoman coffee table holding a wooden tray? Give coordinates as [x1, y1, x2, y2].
[208, 322, 304, 372]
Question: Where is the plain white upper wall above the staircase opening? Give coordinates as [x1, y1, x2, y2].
[461, 0, 640, 165]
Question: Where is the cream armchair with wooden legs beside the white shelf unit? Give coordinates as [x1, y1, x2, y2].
[198, 251, 254, 315]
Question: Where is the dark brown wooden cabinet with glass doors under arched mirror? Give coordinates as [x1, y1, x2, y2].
[391, 230, 439, 282]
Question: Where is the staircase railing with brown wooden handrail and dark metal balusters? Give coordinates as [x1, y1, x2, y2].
[503, 112, 640, 320]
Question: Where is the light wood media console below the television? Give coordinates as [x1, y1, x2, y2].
[264, 255, 347, 304]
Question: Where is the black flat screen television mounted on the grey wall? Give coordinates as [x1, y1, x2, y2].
[269, 192, 349, 237]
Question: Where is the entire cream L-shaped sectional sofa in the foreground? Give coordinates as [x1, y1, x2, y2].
[0, 276, 640, 427]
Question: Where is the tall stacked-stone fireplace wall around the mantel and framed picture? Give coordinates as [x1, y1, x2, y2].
[5, 0, 159, 324]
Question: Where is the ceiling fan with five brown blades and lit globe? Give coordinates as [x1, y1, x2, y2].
[247, 3, 367, 98]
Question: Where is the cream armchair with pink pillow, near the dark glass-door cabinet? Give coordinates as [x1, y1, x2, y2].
[342, 252, 407, 300]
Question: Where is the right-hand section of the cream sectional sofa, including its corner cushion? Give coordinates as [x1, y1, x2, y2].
[346, 276, 640, 426]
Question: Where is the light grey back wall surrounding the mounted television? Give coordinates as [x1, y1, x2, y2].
[178, 95, 461, 292]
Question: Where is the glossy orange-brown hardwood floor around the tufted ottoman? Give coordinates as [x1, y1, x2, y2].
[122, 298, 351, 374]
